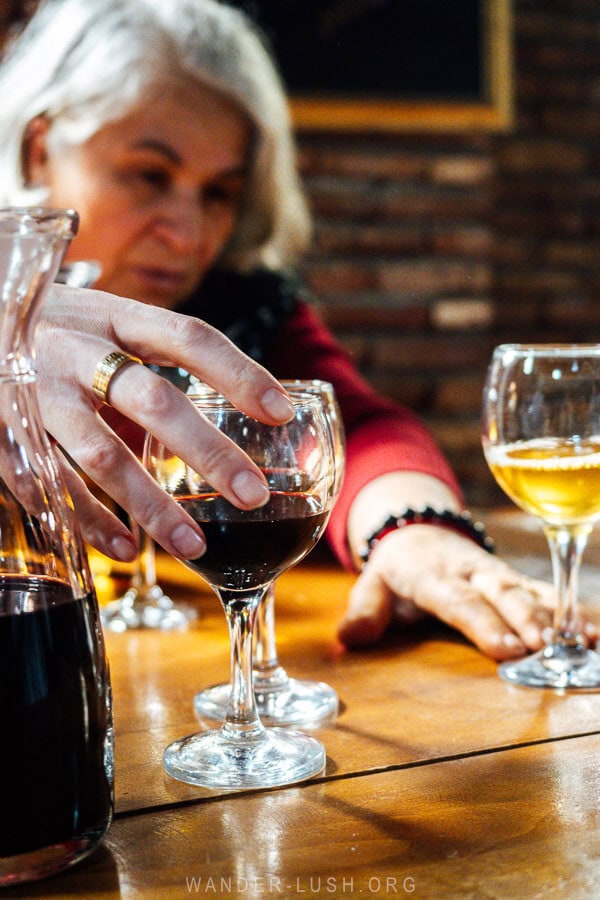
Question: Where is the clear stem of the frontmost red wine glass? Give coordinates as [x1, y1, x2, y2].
[217, 588, 266, 741]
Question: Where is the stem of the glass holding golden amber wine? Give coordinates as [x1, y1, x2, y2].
[544, 525, 592, 649]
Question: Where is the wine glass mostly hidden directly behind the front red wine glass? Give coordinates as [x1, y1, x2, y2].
[194, 379, 346, 728]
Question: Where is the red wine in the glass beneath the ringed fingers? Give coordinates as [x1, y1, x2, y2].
[177, 492, 328, 591]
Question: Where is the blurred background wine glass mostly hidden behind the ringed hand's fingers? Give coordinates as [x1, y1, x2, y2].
[101, 365, 198, 632]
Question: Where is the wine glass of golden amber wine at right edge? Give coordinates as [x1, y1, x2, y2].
[482, 344, 600, 688]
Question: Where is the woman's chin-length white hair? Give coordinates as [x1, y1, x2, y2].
[0, 0, 310, 269]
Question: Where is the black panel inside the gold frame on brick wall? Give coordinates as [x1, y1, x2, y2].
[234, 0, 485, 101]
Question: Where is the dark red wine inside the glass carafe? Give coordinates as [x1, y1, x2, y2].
[0, 575, 113, 857]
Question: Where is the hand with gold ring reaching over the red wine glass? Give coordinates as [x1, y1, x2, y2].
[36, 285, 292, 560]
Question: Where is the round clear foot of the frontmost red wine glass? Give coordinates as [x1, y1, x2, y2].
[163, 726, 326, 790]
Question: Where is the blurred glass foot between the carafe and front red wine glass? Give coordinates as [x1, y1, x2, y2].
[100, 584, 198, 633]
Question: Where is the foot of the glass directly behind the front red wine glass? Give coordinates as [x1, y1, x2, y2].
[194, 678, 339, 728]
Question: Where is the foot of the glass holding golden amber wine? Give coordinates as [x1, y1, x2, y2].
[498, 645, 600, 690]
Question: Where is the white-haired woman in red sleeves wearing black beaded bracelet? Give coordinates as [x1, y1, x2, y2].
[0, 0, 564, 659]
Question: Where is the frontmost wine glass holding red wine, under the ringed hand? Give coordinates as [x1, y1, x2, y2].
[144, 394, 334, 789]
